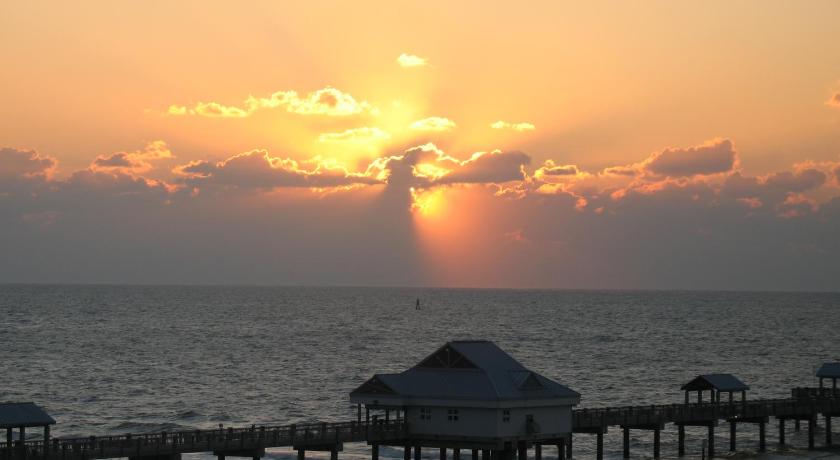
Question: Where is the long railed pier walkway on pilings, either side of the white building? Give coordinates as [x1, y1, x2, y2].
[6, 388, 840, 460]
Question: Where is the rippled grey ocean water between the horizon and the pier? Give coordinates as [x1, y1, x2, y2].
[0, 285, 840, 458]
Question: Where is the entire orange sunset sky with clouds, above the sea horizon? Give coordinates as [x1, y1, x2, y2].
[0, 1, 840, 290]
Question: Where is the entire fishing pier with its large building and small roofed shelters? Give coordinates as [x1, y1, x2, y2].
[0, 342, 840, 460]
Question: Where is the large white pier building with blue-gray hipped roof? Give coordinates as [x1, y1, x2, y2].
[350, 341, 580, 459]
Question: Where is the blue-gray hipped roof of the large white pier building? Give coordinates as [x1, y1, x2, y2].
[351, 341, 580, 400]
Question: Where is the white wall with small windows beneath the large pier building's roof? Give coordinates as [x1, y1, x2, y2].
[406, 406, 572, 437]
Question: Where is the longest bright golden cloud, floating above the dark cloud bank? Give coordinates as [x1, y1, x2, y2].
[166, 87, 379, 118]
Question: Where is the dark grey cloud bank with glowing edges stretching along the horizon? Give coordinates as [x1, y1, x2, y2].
[0, 134, 840, 289]
